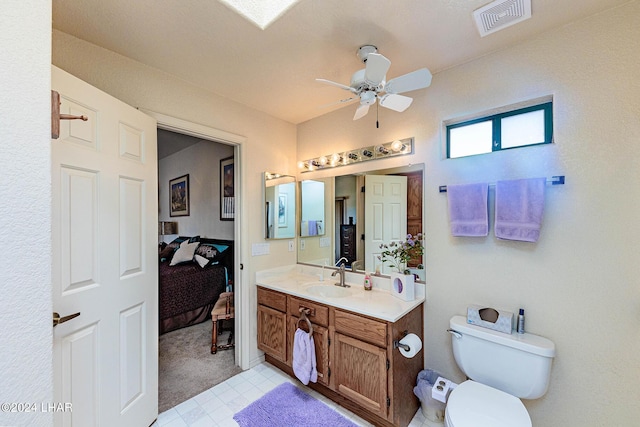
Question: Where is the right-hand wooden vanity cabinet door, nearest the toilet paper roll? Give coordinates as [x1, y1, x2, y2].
[331, 333, 388, 419]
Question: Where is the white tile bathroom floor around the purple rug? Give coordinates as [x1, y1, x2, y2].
[152, 362, 443, 427]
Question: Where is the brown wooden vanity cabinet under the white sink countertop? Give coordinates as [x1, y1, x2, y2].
[258, 287, 424, 427]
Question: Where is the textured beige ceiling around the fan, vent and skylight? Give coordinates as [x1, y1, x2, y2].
[53, 0, 628, 123]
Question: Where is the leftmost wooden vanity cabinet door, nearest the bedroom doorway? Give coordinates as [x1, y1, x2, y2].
[258, 305, 287, 362]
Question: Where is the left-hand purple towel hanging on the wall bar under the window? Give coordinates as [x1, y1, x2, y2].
[447, 183, 489, 237]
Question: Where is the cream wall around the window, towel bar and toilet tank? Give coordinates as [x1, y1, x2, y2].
[298, 1, 640, 427]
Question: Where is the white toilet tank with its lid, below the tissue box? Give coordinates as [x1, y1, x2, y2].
[449, 316, 555, 399]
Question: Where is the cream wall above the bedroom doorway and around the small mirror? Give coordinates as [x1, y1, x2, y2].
[53, 30, 296, 372]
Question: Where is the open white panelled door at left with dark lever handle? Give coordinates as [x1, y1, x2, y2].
[51, 67, 158, 427]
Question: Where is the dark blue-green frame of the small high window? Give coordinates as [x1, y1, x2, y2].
[446, 101, 553, 159]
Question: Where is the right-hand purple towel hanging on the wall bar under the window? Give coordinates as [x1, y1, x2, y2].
[495, 178, 546, 242]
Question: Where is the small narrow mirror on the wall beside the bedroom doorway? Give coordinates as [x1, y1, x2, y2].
[264, 172, 297, 239]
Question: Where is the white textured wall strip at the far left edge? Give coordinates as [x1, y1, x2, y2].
[0, 0, 53, 426]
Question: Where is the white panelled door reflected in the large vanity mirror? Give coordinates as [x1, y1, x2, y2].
[364, 175, 407, 274]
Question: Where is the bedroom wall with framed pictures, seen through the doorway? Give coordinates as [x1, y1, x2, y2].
[158, 141, 234, 240]
